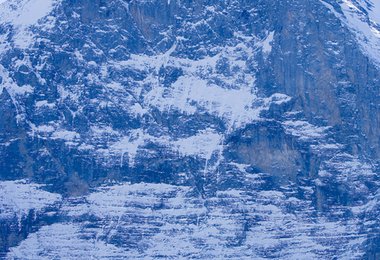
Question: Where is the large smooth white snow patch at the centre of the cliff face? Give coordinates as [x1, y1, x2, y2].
[146, 76, 261, 128]
